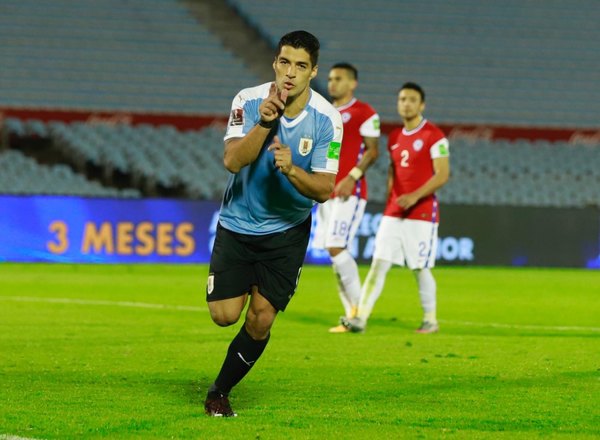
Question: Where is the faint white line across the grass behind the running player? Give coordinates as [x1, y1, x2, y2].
[0, 295, 600, 332]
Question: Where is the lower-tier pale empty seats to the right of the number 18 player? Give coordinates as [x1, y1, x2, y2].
[356, 132, 600, 207]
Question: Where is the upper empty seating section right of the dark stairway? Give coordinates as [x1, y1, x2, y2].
[229, 0, 600, 127]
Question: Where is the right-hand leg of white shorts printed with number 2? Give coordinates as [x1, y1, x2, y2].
[402, 219, 438, 269]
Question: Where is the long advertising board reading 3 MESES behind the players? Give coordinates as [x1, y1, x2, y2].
[0, 196, 600, 268]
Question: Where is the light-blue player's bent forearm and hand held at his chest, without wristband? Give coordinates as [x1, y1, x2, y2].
[268, 136, 335, 203]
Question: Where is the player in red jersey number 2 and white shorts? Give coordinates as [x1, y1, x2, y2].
[344, 83, 450, 333]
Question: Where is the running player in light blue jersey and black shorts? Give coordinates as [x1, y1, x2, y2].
[204, 31, 343, 417]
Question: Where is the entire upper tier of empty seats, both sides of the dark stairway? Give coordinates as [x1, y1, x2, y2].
[0, 0, 600, 127]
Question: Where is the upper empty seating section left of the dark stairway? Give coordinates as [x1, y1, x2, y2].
[0, 0, 258, 114]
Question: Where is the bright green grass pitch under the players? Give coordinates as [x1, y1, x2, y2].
[0, 263, 600, 440]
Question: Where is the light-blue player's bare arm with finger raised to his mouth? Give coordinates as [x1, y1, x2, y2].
[223, 83, 287, 173]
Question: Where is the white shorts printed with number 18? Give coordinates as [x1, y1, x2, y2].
[312, 196, 367, 249]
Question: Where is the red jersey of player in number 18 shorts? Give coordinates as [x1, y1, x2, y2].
[335, 98, 380, 199]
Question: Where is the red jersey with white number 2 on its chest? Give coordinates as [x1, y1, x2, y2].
[383, 119, 450, 223]
